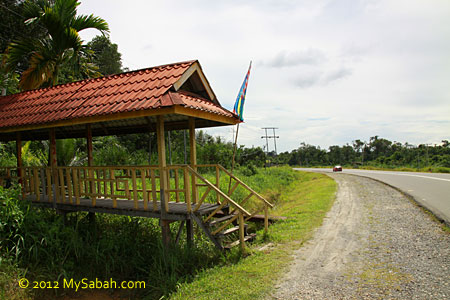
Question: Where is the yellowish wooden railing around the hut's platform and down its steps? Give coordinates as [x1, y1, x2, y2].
[0, 164, 273, 241]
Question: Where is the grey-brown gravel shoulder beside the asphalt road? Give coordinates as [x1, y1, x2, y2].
[270, 174, 450, 299]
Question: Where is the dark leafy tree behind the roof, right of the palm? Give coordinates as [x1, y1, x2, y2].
[88, 35, 123, 75]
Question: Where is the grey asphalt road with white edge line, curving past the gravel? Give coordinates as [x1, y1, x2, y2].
[296, 168, 450, 225]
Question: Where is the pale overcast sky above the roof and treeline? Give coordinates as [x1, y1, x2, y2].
[78, 0, 450, 153]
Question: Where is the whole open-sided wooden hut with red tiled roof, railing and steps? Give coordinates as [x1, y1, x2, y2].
[0, 60, 272, 249]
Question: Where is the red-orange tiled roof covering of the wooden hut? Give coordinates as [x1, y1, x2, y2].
[0, 60, 235, 130]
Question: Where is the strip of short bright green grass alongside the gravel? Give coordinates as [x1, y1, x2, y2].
[170, 172, 336, 299]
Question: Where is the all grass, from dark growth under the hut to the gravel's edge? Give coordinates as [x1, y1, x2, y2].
[0, 167, 336, 299]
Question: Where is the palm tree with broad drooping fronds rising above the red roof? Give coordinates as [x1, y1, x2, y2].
[6, 0, 109, 90]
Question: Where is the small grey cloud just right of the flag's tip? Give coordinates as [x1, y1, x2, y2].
[262, 49, 326, 68]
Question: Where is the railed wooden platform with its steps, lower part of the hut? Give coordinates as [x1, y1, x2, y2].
[4, 165, 273, 249]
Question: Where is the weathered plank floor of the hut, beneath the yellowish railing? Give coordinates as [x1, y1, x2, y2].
[27, 195, 219, 221]
